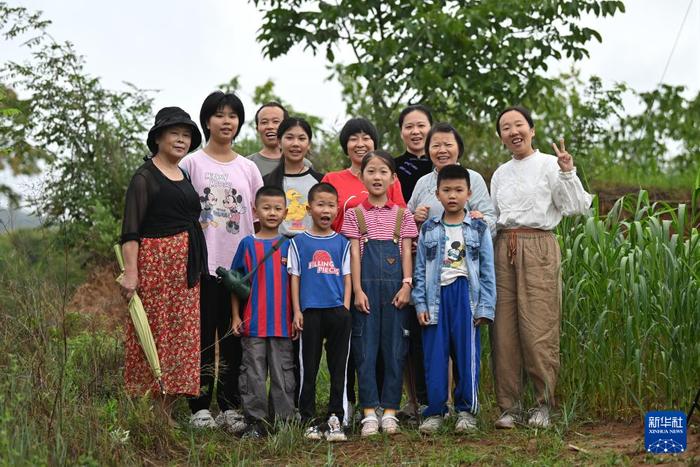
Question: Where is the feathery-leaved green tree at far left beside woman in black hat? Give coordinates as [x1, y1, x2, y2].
[0, 3, 152, 256]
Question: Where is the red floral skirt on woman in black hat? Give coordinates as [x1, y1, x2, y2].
[124, 232, 200, 395]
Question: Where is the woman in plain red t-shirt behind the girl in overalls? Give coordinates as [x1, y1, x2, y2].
[322, 118, 406, 232]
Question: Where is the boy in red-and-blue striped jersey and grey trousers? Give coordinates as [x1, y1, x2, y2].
[231, 186, 294, 438]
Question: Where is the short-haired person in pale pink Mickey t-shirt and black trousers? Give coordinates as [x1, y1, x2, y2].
[180, 91, 263, 431]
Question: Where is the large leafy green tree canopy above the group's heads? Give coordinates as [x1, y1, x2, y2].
[252, 0, 624, 147]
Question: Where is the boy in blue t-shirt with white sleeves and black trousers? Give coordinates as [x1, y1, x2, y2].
[289, 183, 352, 441]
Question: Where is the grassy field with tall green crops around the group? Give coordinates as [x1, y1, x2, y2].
[0, 189, 700, 465]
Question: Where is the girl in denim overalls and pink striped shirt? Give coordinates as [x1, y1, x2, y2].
[342, 151, 418, 436]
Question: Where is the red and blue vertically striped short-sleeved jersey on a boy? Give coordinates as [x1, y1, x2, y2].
[231, 235, 292, 337]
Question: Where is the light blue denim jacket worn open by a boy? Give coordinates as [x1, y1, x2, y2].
[411, 215, 496, 324]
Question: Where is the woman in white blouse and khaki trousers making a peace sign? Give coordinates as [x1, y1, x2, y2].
[491, 106, 592, 428]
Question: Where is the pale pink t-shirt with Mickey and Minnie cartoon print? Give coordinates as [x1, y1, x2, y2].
[180, 149, 263, 276]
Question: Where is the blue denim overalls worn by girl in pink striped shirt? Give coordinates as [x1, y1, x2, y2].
[352, 240, 409, 409]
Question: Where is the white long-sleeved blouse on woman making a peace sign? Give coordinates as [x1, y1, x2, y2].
[491, 151, 593, 230]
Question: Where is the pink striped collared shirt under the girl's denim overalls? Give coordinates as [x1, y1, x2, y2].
[341, 199, 418, 257]
